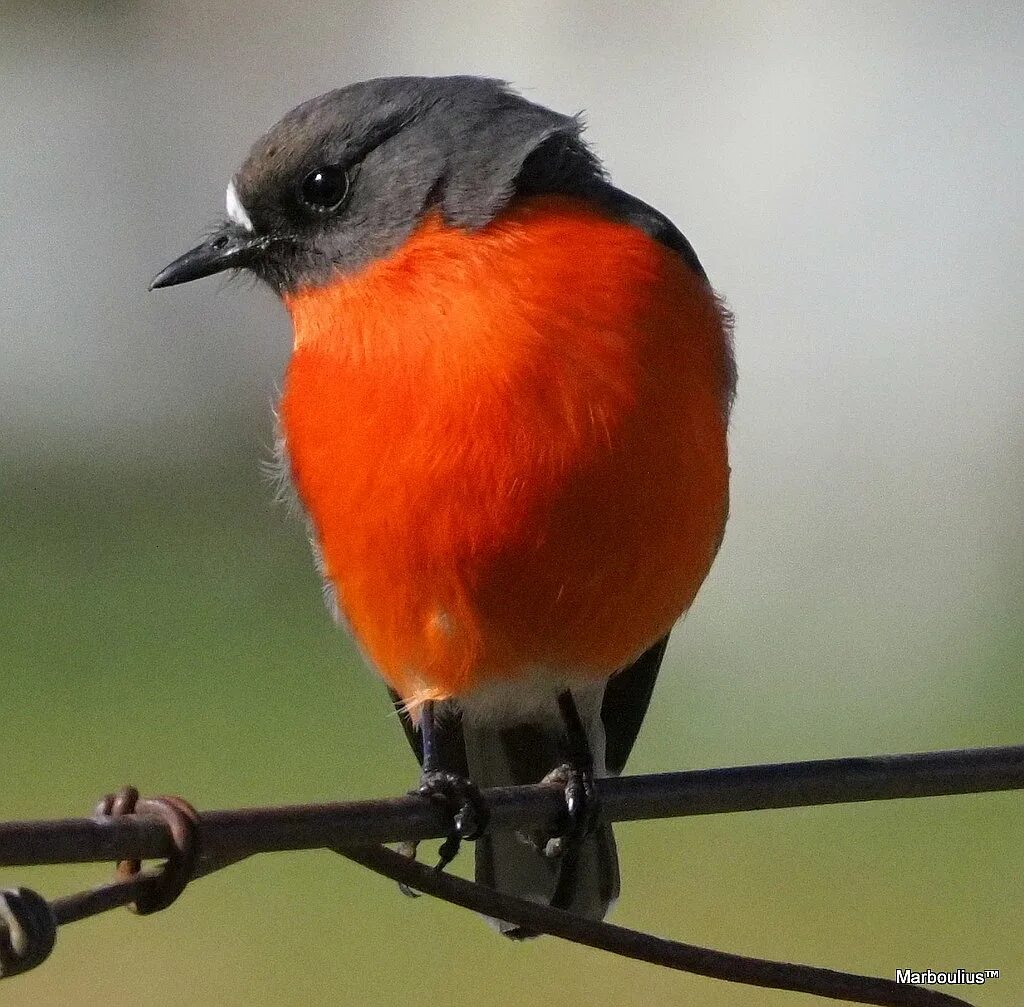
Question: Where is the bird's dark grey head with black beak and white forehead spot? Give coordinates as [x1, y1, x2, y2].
[153, 77, 606, 293]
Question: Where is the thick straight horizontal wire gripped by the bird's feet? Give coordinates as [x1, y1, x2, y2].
[0, 745, 1024, 867]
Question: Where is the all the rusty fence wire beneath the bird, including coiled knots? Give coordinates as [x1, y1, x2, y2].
[0, 746, 1024, 1007]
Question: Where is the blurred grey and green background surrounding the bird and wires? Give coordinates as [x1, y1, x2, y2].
[0, 0, 1024, 1007]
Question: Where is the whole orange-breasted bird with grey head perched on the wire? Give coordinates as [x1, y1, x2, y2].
[153, 77, 735, 936]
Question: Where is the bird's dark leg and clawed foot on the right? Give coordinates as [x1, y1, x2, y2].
[545, 689, 600, 909]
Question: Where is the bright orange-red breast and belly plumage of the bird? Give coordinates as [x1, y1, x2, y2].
[281, 197, 730, 702]
